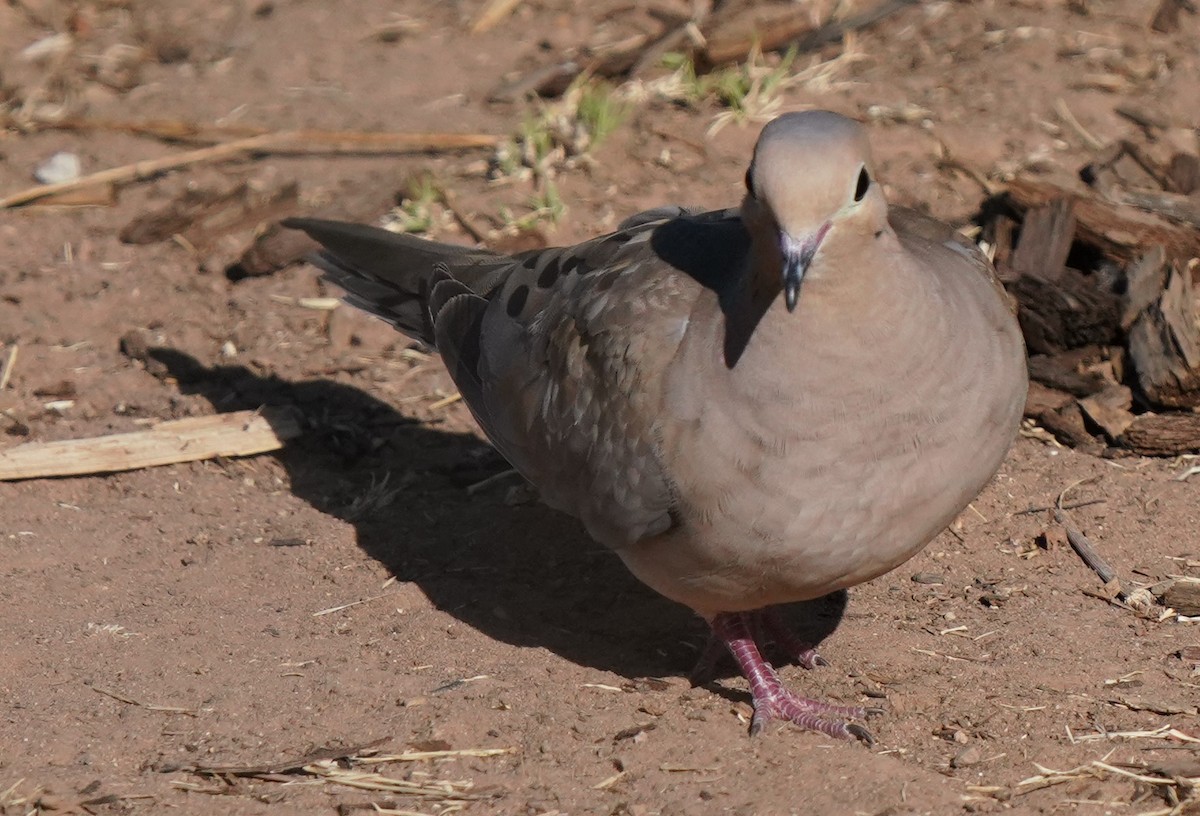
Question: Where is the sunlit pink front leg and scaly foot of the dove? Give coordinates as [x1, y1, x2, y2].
[710, 612, 875, 745]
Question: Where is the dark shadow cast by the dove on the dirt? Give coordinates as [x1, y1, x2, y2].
[146, 348, 845, 678]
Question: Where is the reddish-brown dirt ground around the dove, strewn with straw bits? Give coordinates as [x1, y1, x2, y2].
[0, 0, 1200, 816]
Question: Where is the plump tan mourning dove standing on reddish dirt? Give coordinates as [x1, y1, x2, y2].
[284, 112, 1027, 742]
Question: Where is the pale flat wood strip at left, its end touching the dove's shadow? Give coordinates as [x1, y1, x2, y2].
[0, 408, 301, 481]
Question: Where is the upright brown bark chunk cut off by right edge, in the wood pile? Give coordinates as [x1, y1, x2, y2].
[1129, 265, 1200, 408]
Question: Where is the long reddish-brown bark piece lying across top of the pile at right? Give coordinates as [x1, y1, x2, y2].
[1007, 175, 1200, 263]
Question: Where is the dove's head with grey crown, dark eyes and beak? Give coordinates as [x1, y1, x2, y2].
[742, 110, 888, 311]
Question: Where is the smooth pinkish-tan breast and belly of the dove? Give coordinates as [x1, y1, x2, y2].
[620, 229, 1026, 613]
